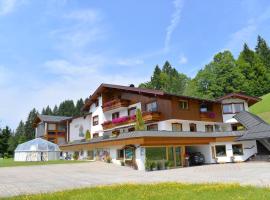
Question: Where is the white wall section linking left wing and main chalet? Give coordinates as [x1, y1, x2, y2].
[69, 115, 92, 142]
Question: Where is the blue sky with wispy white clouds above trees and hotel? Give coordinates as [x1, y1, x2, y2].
[0, 0, 270, 129]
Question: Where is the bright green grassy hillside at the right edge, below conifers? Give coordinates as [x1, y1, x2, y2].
[249, 93, 270, 123]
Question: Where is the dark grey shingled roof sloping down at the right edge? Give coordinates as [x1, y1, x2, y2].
[234, 111, 270, 141]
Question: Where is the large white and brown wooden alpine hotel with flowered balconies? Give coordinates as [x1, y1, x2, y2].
[35, 84, 268, 170]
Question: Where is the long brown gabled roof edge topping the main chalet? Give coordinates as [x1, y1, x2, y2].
[83, 83, 217, 110]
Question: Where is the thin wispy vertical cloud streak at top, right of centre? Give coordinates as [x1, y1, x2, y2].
[164, 0, 184, 52]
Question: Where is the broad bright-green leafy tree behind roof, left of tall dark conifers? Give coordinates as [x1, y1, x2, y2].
[188, 51, 243, 99]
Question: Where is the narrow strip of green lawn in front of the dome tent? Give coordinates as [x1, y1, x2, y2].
[0, 158, 86, 167]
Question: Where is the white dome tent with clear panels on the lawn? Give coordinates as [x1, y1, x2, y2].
[14, 138, 60, 161]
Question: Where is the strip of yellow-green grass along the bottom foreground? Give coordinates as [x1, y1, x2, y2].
[3, 183, 270, 200]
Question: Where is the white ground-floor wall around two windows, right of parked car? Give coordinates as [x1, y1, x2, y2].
[210, 140, 257, 163]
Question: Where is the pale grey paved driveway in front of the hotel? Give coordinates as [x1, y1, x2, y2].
[0, 162, 270, 197]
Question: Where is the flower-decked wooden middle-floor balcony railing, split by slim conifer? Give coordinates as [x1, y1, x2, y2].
[102, 112, 161, 130]
